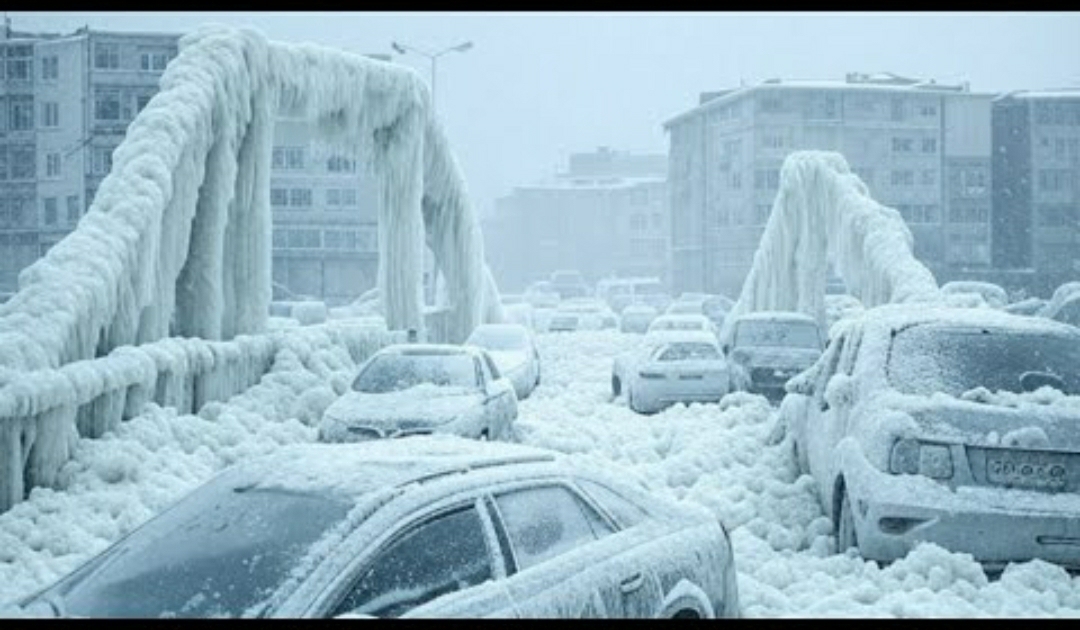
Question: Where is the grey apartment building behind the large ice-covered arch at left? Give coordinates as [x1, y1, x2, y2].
[0, 24, 386, 304]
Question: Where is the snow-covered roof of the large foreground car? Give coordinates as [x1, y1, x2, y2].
[232, 434, 556, 500]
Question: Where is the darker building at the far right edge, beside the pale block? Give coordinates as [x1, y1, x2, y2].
[993, 89, 1080, 296]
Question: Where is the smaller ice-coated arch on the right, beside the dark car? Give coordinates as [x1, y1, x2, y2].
[720, 151, 941, 339]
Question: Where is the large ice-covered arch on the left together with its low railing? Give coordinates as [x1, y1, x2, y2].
[0, 27, 500, 511]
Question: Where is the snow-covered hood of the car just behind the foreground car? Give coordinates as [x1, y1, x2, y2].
[323, 386, 484, 428]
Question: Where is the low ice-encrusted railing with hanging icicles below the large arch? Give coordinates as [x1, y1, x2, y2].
[0, 320, 405, 512]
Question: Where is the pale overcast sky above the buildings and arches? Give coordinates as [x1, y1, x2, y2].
[9, 12, 1080, 212]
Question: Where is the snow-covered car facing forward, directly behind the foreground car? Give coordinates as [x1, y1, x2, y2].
[319, 344, 517, 442]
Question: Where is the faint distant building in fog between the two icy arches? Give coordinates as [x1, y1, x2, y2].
[484, 147, 669, 292]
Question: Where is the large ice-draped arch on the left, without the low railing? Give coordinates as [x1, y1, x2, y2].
[0, 26, 500, 378]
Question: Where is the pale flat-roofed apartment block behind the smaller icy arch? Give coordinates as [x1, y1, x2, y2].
[664, 73, 993, 297]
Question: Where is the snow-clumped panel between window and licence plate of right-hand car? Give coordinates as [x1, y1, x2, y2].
[906, 393, 1080, 451]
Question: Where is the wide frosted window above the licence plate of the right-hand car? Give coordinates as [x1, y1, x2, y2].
[888, 324, 1080, 396]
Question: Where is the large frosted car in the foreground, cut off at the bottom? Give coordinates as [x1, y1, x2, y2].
[19, 435, 739, 618]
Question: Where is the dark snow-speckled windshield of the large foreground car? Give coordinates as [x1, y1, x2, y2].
[41, 479, 351, 618]
